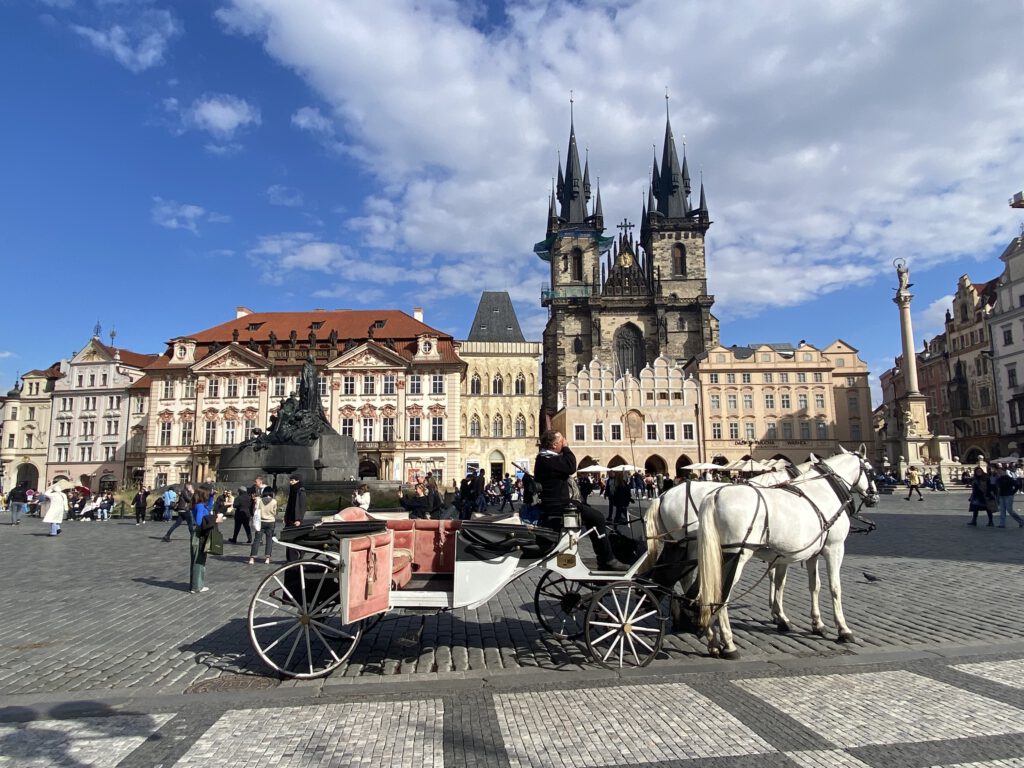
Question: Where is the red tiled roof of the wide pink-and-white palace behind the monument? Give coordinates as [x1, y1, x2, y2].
[147, 309, 463, 371]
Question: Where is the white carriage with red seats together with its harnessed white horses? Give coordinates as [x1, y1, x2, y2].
[248, 453, 874, 678]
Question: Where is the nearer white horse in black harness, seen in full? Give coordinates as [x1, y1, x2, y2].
[697, 446, 879, 658]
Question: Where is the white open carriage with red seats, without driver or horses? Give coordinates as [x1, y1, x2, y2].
[248, 509, 666, 678]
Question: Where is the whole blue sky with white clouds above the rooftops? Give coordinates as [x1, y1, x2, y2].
[0, 0, 1024, 409]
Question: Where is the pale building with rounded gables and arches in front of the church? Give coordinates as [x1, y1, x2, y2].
[552, 355, 700, 476]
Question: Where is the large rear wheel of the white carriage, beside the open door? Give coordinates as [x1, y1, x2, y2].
[249, 560, 362, 679]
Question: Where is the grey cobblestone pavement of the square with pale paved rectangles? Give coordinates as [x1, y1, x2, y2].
[0, 492, 1024, 768]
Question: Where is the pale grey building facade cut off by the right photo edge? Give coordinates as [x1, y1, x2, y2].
[988, 237, 1024, 458]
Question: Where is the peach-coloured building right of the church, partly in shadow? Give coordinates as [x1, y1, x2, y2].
[686, 340, 871, 465]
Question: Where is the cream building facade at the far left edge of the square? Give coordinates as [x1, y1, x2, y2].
[0, 362, 63, 490]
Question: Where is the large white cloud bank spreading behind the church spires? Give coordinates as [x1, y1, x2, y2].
[217, 0, 1024, 331]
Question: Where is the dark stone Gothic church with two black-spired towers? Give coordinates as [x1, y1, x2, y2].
[534, 108, 719, 416]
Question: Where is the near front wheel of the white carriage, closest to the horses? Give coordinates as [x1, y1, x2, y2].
[586, 582, 665, 668]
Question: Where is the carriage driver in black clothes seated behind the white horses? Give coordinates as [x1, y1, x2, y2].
[534, 429, 629, 571]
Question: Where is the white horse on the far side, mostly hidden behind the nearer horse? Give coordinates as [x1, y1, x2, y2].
[640, 462, 814, 631]
